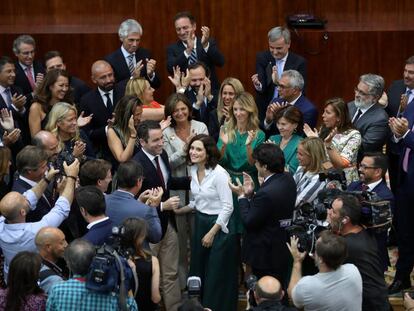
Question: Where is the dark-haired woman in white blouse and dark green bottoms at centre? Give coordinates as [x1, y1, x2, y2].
[176, 134, 238, 311]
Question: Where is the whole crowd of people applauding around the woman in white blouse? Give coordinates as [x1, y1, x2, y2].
[0, 12, 414, 311]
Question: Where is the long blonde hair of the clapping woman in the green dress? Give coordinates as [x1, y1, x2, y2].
[226, 92, 259, 142]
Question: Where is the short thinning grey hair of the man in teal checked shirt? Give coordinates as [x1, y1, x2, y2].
[64, 239, 95, 275]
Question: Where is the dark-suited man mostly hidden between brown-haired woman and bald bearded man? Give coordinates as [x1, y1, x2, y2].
[45, 51, 91, 104]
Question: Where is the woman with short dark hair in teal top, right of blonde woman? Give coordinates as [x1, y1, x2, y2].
[269, 105, 303, 175]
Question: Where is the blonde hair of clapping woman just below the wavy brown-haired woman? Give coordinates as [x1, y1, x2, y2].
[45, 102, 79, 150]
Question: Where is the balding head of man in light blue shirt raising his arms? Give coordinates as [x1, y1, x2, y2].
[0, 191, 30, 223]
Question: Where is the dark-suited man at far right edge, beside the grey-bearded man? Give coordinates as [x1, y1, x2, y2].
[385, 56, 414, 194]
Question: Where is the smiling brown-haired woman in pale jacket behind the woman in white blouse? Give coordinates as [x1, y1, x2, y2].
[163, 94, 208, 289]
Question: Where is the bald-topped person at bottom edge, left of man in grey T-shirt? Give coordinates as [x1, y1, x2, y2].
[246, 276, 296, 311]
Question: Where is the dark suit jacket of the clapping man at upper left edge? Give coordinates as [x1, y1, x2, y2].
[0, 85, 31, 146]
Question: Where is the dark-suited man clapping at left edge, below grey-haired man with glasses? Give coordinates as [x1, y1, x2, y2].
[0, 56, 30, 146]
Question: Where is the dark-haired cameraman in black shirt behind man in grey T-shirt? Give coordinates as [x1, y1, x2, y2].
[327, 195, 390, 311]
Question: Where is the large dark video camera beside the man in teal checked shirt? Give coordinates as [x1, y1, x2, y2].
[86, 227, 138, 310]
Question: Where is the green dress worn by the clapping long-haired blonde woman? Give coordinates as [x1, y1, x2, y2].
[217, 130, 266, 233]
